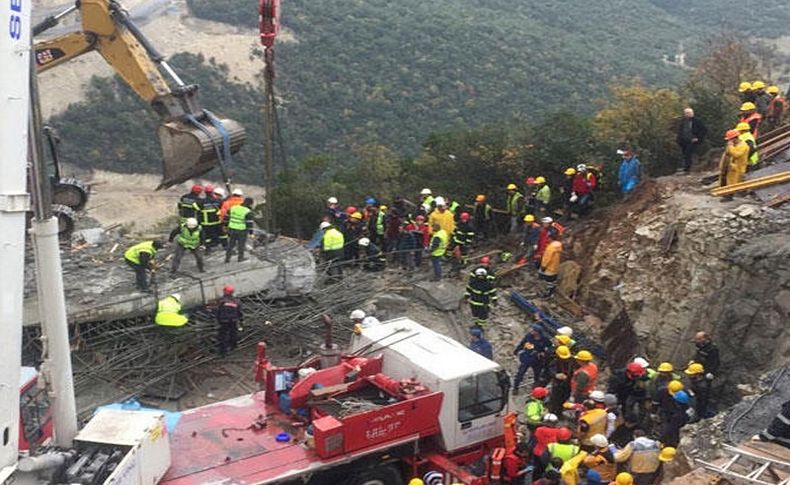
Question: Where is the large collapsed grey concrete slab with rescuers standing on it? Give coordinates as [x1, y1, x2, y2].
[23, 234, 316, 326]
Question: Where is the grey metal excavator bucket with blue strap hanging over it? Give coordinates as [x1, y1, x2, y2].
[157, 119, 247, 189]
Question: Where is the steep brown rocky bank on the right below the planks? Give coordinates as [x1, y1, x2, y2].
[572, 176, 790, 392]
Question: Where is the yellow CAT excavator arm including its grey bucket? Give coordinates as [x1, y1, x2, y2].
[34, 0, 246, 188]
